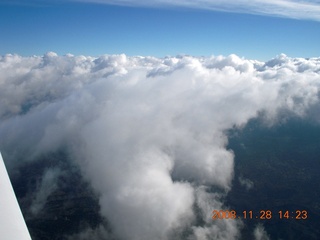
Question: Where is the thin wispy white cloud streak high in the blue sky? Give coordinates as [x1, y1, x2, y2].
[72, 0, 320, 21]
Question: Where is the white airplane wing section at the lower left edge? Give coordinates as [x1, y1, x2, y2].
[0, 153, 31, 240]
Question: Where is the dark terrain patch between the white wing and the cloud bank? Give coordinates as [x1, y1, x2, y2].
[12, 151, 103, 240]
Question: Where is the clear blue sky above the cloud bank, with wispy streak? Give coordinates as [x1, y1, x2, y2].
[0, 0, 320, 61]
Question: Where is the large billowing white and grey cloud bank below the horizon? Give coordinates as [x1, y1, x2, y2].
[0, 53, 320, 240]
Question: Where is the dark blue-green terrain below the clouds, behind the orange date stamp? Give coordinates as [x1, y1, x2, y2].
[226, 118, 320, 240]
